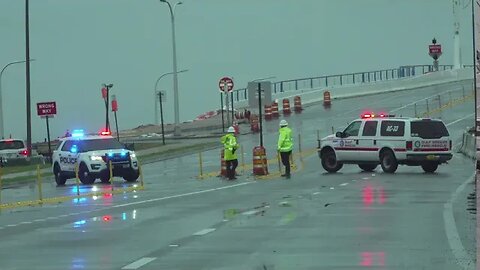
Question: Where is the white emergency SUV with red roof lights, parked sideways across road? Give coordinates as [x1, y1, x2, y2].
[318, 113, 452, 173]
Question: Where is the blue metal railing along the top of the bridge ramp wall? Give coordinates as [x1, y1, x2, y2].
[232, 65, 473, 102]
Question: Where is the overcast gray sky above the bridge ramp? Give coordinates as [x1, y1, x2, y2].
[0, 0, 472, 140]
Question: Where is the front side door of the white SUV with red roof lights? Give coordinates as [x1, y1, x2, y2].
[335, 121, 362, 161]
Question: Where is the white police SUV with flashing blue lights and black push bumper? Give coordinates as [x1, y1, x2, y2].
[52, 130, 140, 185]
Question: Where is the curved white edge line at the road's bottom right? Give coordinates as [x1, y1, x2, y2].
[443, 174, 475, 270]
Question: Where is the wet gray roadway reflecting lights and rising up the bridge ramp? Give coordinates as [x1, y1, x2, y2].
[0, 80, 475, 270]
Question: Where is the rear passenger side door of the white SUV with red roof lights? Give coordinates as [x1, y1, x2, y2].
[357, 120, 379, 161]
